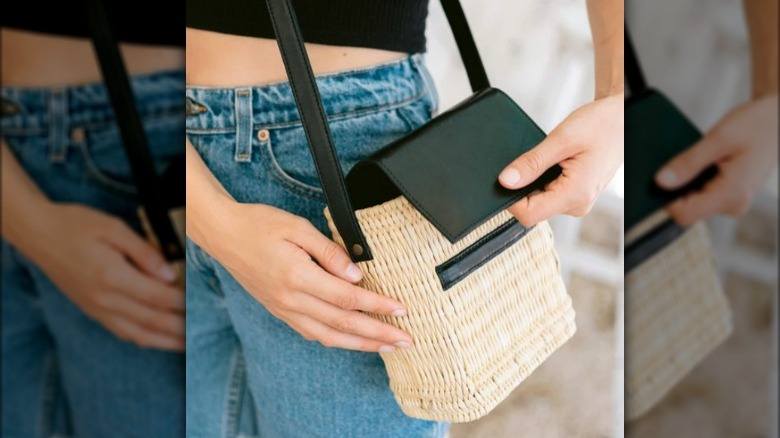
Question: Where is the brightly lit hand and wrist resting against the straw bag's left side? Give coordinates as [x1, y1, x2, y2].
[187, 144, 412, 352]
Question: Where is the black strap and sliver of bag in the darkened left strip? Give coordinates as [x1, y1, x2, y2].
[84, 0, 185, 287]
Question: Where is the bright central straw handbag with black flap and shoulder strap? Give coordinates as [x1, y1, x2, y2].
[266, 0, 575, 422]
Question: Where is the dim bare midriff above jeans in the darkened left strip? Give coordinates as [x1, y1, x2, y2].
[0, 28, 184, 87]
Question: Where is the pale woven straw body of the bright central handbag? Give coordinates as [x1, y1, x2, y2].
[325, 197, 575, 422]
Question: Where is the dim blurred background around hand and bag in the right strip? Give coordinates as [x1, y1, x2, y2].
[626, 0, 778, 437]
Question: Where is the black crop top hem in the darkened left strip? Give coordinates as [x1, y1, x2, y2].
[0, 0, 185, 47]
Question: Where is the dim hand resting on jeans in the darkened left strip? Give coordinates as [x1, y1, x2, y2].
[23, 204, 185, 351]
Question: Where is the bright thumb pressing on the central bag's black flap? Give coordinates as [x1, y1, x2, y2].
[498, 133, 569, 189]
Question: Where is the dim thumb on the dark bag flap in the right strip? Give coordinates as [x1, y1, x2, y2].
[655, 137, 725, 190]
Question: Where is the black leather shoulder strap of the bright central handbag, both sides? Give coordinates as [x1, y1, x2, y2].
[266, 0, 490, 262]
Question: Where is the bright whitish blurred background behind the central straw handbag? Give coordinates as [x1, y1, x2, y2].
[427, 0, 623, 438]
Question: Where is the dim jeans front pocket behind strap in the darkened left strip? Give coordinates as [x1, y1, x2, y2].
[78, 114, 184, 195]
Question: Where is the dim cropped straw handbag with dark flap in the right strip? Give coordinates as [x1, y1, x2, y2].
[624, 33, 732, 420]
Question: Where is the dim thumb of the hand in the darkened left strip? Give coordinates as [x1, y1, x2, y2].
[106, 220, 178, 282]
